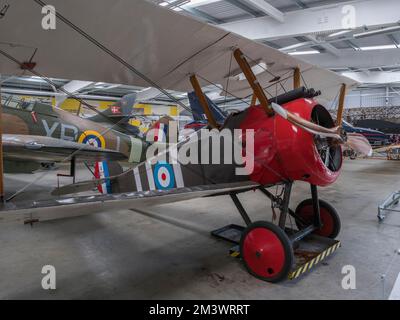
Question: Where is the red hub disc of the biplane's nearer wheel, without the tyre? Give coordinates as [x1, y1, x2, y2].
[242, 228, 285, 278]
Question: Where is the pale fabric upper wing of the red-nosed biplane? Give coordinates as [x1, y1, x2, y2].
[0, 0, 356, 99]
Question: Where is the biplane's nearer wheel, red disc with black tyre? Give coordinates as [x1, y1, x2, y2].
[240, 221, 294, 282]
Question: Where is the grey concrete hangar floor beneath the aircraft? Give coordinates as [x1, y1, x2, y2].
[0, 160, 400, 300]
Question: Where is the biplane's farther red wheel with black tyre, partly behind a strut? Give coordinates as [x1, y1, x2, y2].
[295, 199, 340, 239]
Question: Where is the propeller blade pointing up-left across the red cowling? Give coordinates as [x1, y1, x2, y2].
[271, 102, 343, 141]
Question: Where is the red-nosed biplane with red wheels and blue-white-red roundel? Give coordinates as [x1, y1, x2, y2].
[0, 0, 376, 282]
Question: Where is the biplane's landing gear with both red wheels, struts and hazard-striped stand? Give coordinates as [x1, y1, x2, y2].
[219, 182, 340, 282]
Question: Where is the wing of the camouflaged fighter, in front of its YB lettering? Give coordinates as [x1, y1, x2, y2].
[2, 134, 126, 162]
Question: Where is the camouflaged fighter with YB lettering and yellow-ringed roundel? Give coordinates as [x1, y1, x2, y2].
[2, 92, 145, 173]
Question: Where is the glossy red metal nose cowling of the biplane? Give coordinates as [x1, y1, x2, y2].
[240, 99, 342, 186]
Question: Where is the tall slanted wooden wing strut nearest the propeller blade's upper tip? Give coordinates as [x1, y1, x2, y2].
[233, 49, 274, 116]
